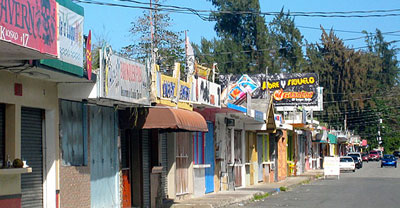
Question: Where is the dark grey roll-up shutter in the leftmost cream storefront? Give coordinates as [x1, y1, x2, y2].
[21, 108, 43, 207]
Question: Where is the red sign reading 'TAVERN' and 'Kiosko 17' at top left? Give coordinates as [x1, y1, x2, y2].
[0, 0, 58, 56]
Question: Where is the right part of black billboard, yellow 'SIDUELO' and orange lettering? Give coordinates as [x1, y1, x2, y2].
[268, 73, 318, 106]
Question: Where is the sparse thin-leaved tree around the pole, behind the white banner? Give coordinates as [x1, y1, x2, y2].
[122, 0, 185, 68]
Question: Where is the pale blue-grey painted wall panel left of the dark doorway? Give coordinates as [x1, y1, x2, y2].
[89, 106, 120, 208]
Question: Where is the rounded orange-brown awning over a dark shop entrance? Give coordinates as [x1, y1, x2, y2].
[143, 108, 208, 132]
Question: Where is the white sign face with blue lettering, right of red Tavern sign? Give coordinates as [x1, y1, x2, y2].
[57, 3, 84, 67]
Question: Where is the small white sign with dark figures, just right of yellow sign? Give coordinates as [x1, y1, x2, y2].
[193, 77, 221, 108]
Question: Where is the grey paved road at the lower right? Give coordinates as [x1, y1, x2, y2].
[236, 158, 400, 208]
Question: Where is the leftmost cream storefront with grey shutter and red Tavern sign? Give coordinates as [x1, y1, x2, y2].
[0, 0, 60, 207]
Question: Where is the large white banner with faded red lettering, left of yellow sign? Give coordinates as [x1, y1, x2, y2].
[98, 47, 150, 105]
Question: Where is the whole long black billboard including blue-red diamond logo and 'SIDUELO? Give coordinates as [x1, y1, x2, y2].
[219, 73, 323, 111]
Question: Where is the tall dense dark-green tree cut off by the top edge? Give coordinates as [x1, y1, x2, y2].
[210, 0, 271, 73]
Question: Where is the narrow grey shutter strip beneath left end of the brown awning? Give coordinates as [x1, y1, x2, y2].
[142, 130, 150, 207]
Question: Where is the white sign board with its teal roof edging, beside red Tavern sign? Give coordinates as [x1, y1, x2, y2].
[41, 0, 84, 76]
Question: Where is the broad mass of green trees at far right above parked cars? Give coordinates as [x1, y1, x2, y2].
[305, 28, 400, 150]
